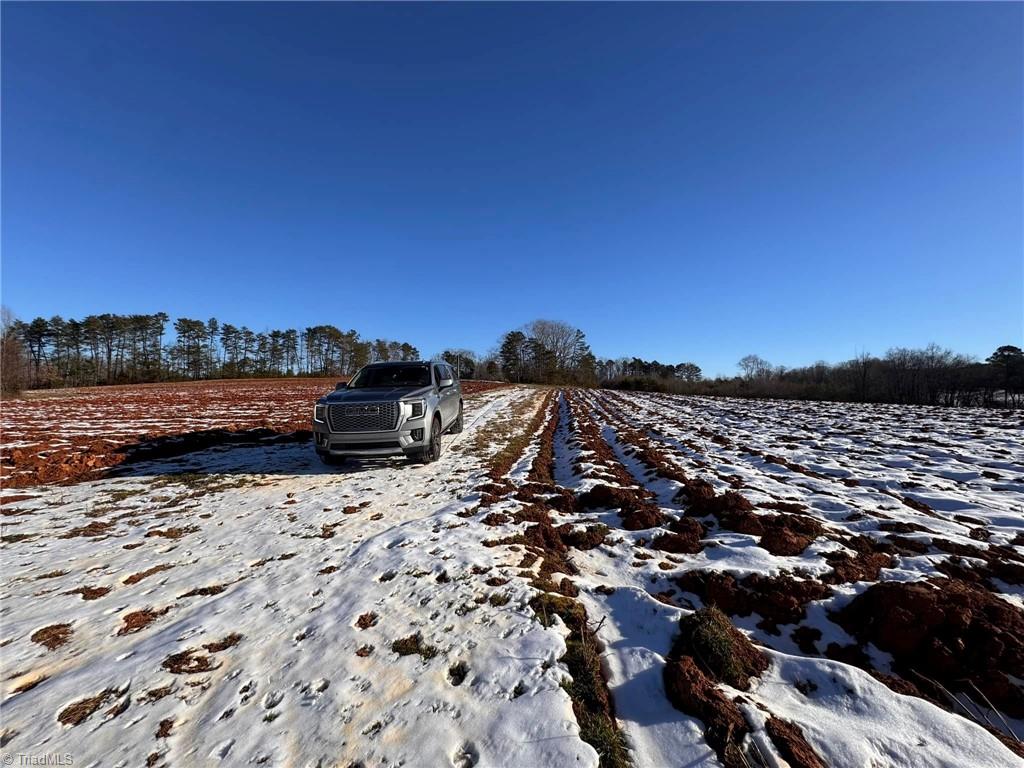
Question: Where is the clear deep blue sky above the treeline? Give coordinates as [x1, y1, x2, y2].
[2, 2, 1024, 373]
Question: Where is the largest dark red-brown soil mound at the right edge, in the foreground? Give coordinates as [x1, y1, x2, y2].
[834, 580, 1024, 718]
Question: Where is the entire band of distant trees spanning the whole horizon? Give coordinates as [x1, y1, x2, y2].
[0, 312, 1024, 408]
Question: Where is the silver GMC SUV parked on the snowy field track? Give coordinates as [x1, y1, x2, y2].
[313, 362, 462, 464]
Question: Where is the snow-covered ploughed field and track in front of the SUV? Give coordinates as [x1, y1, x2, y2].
[0, 388, 1024, 768]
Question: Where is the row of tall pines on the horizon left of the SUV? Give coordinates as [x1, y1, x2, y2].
[2, 312, 420, 391]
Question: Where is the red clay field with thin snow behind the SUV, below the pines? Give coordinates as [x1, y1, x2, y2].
[0, 378, 505, 487]
